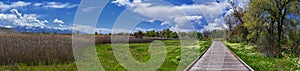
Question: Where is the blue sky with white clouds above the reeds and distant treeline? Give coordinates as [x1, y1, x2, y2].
[0, 0, 249, 33]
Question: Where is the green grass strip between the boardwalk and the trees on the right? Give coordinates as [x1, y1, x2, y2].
[225, 42, 300, 71]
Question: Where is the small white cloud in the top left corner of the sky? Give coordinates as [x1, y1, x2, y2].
[0, 1, 31, 11]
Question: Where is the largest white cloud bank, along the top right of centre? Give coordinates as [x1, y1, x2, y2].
[112, 0, 229, 30]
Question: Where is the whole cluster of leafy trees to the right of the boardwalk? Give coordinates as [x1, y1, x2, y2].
[225, 0, 300, 57]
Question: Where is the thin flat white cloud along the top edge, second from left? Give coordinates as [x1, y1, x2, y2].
[43, 2, 78, 9]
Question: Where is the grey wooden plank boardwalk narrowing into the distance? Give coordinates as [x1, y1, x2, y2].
[186, 41, 252, 71]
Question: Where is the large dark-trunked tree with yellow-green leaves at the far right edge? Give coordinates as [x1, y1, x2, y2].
[243, 0, 299, 54]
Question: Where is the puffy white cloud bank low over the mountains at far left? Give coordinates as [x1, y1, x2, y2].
[0, 9, 73, 30]
